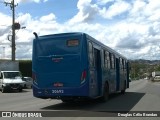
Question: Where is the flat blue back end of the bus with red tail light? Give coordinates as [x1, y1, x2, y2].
[32, 33, 89, 100]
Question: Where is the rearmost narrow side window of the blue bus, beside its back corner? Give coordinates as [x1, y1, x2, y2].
[88, 42, 94, 67]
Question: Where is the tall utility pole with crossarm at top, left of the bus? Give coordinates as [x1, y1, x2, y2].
[4, 0, 17, 61]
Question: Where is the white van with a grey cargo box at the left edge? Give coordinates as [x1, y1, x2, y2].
[0, 61, 25, 93]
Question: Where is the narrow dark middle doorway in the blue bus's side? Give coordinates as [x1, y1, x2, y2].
[116, 58, 120, 91]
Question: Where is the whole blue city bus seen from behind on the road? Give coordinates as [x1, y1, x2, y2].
[32, 32, 129, 102]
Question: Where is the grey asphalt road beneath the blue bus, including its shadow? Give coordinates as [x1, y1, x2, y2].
[0, 80, 160, 120]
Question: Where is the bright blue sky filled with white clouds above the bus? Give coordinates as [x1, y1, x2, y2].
[0, 0, 160, 60]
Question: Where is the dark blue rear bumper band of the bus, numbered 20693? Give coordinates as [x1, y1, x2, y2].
[33, 85, 88, 99]
